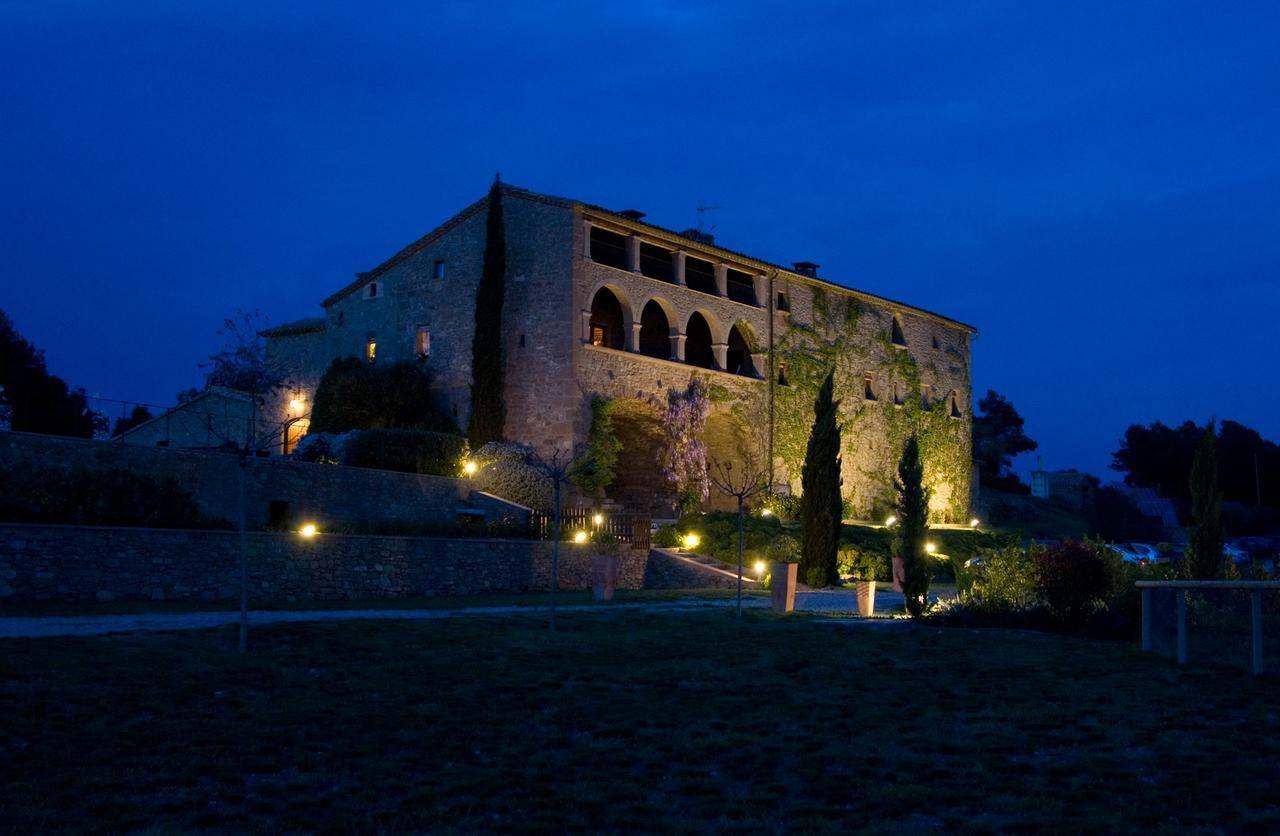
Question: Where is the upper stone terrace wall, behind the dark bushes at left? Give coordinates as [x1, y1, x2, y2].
[0, 433, 527, 529]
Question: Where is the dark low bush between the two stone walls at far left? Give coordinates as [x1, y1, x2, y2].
[0, 465, 232, 529]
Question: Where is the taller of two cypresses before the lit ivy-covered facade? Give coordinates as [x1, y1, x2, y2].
[800, 369, 841, 586]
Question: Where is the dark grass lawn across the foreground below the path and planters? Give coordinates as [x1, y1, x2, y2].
[0, 612, 1280, 833]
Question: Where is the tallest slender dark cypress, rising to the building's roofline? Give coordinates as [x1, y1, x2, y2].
[467, 177, 507, 449]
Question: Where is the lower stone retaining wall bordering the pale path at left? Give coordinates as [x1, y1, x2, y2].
[0, 525, 645, 599]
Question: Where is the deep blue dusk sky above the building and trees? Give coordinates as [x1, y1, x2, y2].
[0, 0, 1280, 475]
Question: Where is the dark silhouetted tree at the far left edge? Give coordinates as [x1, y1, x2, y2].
[0, 305, 105, 438]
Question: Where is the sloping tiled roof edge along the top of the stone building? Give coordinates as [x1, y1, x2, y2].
[314, 184, 978, 335]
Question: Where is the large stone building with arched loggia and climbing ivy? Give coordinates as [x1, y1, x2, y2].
[264, 186, 974, 520]
